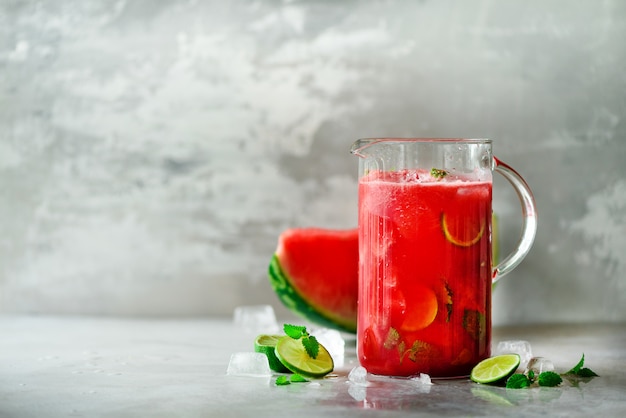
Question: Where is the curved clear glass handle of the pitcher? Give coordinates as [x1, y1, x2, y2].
[492, 157, 537, 283]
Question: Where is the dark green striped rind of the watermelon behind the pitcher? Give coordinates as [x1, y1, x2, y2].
[268, 254, 356, 333]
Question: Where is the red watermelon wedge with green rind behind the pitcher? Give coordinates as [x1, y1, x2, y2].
[269, 228, 359, 333]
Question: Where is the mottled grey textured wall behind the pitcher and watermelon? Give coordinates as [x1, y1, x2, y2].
[0, 0, 626, 324]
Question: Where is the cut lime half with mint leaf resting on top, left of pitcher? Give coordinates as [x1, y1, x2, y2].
[275, 337, 335, 377]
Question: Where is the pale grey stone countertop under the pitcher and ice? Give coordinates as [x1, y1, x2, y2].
[0, 316, 626, 418]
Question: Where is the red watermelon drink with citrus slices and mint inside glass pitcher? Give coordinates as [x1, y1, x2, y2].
[357, 169, 493, 377]
